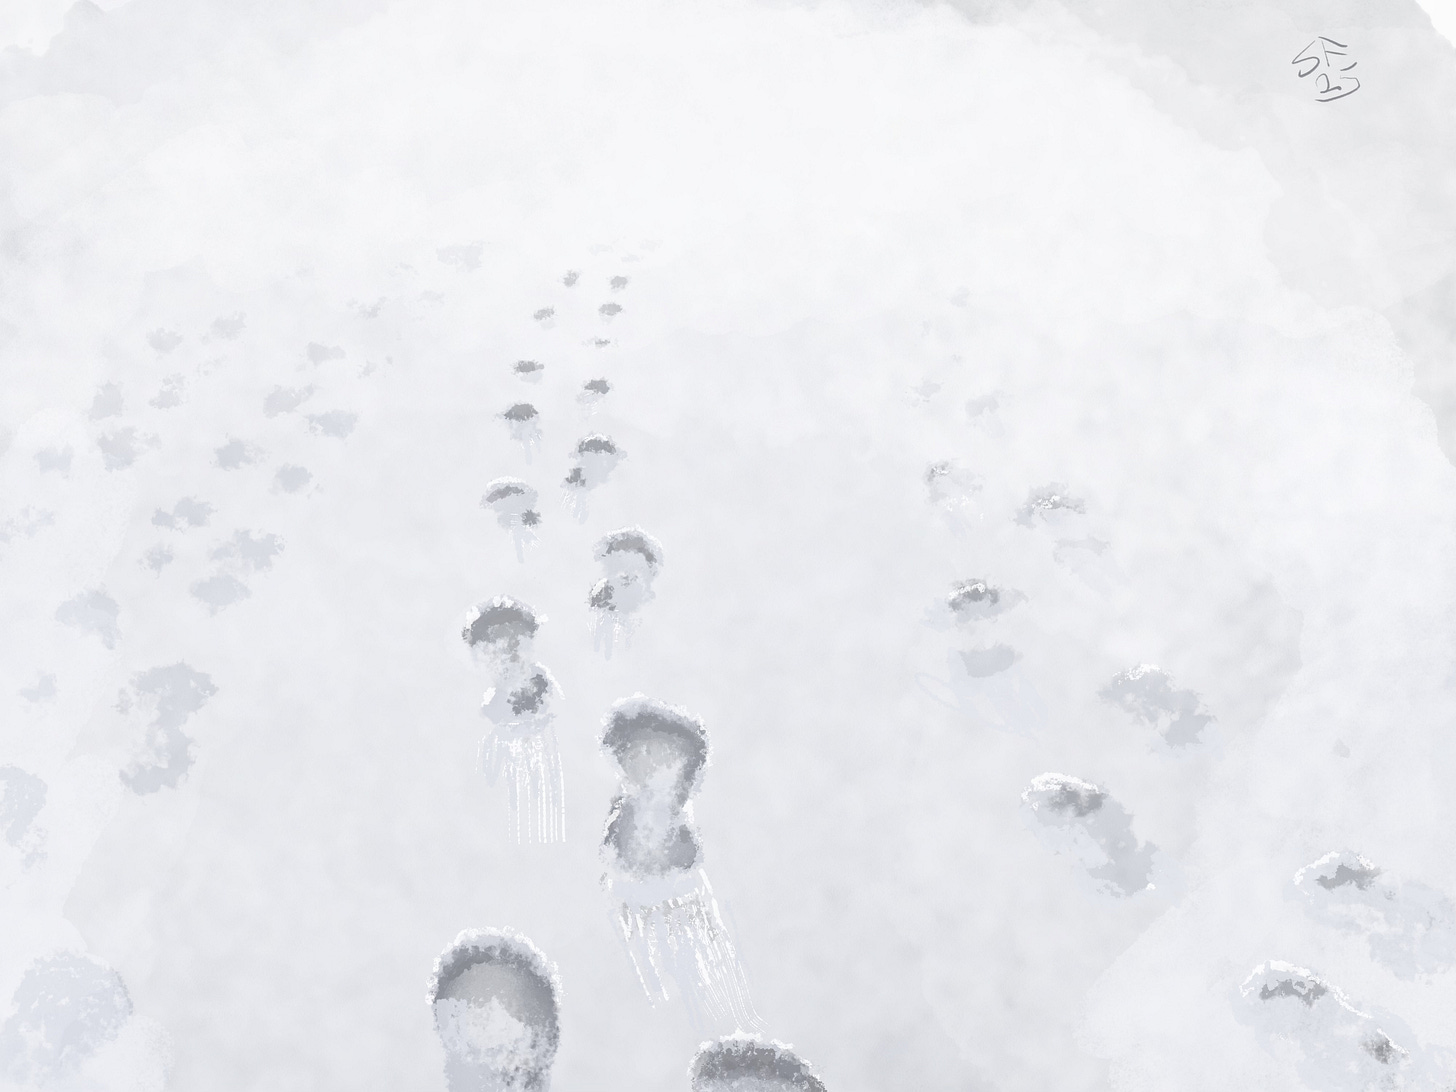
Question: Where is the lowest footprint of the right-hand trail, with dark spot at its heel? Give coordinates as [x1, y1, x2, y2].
[1236, 960, 1425, 1089]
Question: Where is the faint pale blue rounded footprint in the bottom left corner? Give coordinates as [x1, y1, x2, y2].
[0, 952, 131, 1085]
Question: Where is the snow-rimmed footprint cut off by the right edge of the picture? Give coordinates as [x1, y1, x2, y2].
[1294, 849, 1456, 978]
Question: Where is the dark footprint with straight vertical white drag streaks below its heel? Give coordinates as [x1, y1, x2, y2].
[462, 596, 566, 842]
